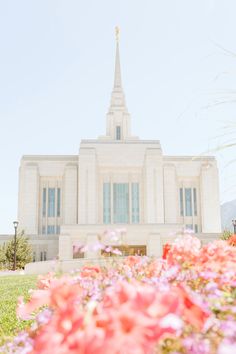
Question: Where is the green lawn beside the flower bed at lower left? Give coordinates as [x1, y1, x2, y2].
[0, 275, 37, 345]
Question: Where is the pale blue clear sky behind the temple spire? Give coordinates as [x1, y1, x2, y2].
[0, 0, 236, 234]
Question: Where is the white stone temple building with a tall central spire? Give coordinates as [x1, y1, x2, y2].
[18, 31, 221, 261]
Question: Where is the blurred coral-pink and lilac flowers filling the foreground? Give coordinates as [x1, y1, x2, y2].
[0, 234, 236, 354]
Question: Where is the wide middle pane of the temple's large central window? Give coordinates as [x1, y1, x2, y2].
[113, 183, 129, 224]
